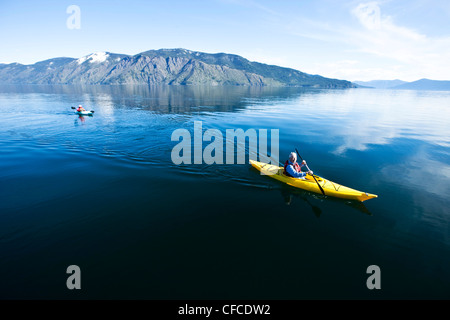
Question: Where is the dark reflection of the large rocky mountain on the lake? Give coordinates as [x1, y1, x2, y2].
[0, 85, 320, 114]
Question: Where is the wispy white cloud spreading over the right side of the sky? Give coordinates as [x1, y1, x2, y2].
[285, 1, 450, 81]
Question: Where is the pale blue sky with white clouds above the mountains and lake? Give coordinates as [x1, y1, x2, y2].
[0, 0, 450, 81]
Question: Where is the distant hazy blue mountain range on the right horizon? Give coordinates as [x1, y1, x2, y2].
[354, 79, 450, 91]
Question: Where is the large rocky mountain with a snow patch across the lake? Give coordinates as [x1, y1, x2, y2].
[0, 49, 356, 88]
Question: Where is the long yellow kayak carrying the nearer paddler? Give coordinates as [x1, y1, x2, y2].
[250, 160, 378, 202]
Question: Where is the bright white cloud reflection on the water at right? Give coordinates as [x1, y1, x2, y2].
[232, 89, 450, 156]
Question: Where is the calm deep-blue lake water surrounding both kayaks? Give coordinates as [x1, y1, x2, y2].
[0, 86, 450, 299]
